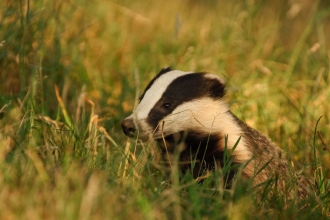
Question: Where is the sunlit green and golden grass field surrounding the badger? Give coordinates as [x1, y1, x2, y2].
[0, 0, 330, 219]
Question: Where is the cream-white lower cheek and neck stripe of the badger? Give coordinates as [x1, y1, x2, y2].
[153, 98, 252, 162]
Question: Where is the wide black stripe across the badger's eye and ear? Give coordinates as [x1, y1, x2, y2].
[147, 73, 225, 128]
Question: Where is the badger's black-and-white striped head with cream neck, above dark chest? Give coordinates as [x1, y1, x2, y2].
[122, 68, 249, 161]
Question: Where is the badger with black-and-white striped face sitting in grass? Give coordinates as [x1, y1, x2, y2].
[121, 68, 312, 198]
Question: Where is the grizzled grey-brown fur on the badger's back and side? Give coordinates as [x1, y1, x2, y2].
[231, 113, 314, 199]
